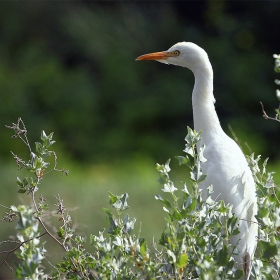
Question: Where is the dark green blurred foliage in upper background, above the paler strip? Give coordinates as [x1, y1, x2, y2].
[0, 1, 280, 162]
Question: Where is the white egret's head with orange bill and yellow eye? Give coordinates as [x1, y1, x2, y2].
[136, 42, 209, 72]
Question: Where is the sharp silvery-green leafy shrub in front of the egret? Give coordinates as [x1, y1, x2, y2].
[0, 119, 280, 279]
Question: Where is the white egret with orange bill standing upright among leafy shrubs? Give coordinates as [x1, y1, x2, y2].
[136, 42, 258, 279]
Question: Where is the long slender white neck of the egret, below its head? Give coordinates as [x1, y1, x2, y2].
[192, 61, 223, 145]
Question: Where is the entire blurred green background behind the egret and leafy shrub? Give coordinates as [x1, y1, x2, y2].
[0, 1, 280, 280]
